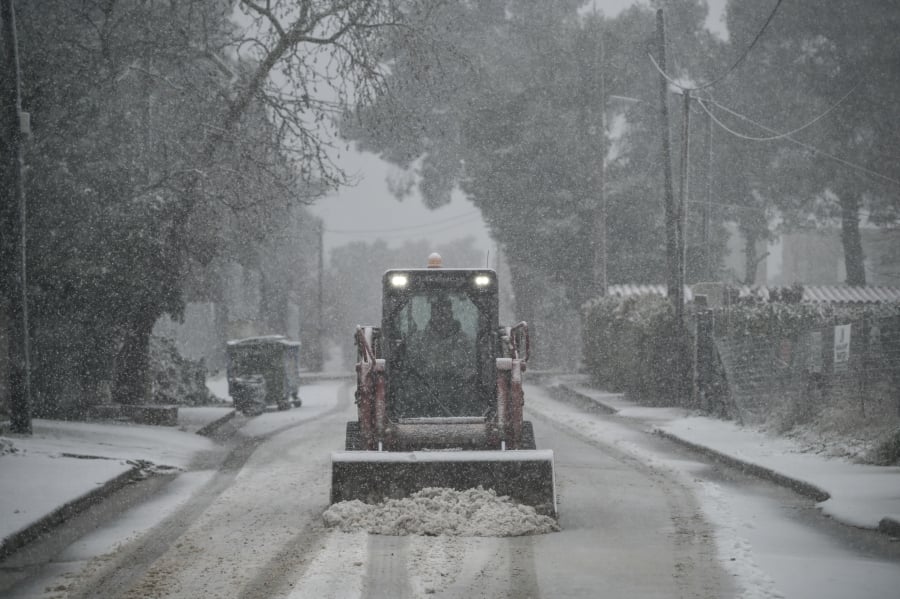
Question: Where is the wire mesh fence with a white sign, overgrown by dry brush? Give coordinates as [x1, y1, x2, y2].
[695, 309, 900, 427]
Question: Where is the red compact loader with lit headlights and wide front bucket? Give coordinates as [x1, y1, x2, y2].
[331, 254, 556, 517]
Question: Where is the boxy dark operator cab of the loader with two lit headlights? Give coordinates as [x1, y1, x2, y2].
[381, 258, 499, 422]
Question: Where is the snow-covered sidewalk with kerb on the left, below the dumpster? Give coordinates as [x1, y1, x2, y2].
[0, 407, 233, 557]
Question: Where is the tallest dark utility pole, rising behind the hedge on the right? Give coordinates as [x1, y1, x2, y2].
[656, 8, 684, 318]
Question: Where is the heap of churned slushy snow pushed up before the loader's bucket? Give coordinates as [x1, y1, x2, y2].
[322, 487, 559, 537]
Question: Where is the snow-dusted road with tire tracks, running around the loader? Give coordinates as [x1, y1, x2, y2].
[9, 382, 900, 599]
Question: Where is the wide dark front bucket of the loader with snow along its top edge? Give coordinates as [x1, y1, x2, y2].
[331, 449, 556, 517]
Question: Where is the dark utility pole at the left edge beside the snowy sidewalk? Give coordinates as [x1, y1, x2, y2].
[0, 0, 31, 434]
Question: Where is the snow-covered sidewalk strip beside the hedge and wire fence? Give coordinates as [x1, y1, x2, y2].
[558, 381, 900, 536]
